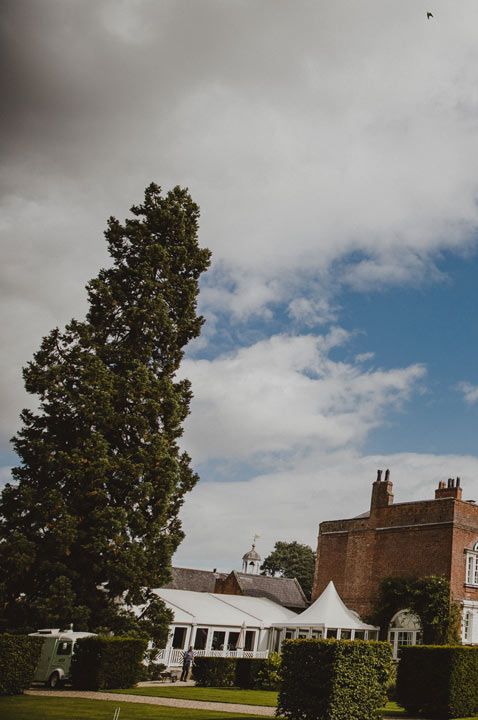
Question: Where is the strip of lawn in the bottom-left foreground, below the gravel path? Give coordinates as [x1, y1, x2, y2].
[0, 695, 264, 720]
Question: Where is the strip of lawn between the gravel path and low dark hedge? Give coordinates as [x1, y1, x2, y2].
[112, 685, 277, 707]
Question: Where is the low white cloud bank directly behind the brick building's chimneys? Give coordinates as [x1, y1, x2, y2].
[174, 450, 478, 570]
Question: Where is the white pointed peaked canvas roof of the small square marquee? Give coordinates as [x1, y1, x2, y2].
[276, 580, 376, 630]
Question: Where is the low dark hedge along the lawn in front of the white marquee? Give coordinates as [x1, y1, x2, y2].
[193, 653, 280, 690]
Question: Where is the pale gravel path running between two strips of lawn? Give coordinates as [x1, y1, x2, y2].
[25, 690, 275, 717]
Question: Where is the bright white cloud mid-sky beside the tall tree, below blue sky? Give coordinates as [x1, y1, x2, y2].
[182, 328, 425, 462]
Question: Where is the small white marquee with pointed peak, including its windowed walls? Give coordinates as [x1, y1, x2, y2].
[269, 580, 379, 651]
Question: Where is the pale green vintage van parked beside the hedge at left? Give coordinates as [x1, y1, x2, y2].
[30, 628, 94, 688]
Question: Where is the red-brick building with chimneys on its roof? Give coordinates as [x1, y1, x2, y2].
[312, 470, 478, 643]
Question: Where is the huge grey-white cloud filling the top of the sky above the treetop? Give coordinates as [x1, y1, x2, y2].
[0, 0, 478, 448]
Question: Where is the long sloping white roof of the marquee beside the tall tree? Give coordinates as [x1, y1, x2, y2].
[153, 588, 297, 627]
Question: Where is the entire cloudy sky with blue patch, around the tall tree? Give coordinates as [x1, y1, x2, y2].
[0, 0, 478, 569]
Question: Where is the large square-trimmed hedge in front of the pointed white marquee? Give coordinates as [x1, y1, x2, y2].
[278, 640, 392, 720]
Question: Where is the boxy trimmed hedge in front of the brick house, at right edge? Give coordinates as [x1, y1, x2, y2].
[397, 645, 478, 718]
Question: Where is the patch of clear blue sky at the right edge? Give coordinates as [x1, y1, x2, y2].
[340, 249, 478, 454]
